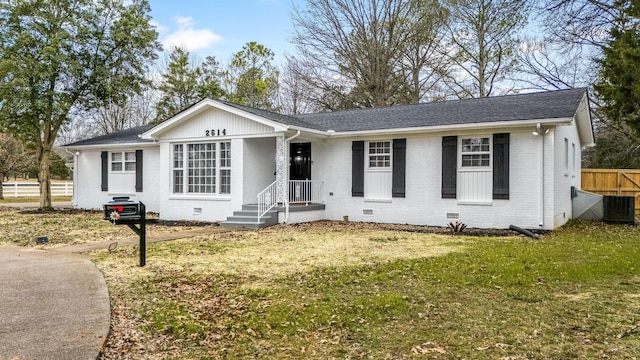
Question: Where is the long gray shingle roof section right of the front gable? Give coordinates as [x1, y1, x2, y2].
[300, 89, 586, 132]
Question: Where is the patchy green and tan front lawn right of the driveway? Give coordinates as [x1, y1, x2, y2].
[95, 222, 640, 359]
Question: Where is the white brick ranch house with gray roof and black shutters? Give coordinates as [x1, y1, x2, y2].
[65, 89, 594, 230]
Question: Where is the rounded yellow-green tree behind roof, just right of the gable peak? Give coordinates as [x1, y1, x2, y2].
[225, 41, 278, 110]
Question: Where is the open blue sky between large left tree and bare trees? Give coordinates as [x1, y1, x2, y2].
[149, 0, 300, 64]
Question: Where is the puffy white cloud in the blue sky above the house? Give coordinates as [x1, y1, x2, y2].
[156, 16, 222, 51]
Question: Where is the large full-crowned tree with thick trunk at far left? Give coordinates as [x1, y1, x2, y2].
[0, 0, 160, 208]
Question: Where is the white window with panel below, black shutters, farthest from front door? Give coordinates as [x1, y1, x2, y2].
[457, 136, 493, 203]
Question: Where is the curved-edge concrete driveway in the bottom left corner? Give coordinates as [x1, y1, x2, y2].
[0, 247, 110, 360]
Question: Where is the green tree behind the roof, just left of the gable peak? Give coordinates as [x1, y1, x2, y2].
[155, 47, 224, 123]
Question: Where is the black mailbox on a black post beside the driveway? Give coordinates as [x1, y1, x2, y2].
[103, 197, 147, 266]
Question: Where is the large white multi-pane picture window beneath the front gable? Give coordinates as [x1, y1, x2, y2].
[171, 141, 232, 197]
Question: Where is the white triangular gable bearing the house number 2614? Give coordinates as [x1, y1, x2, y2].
[158, 107, 274, 140]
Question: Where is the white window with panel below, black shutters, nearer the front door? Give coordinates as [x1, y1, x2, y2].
[364, 141, 393, 200]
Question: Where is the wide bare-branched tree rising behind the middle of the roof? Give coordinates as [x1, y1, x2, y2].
[293, 0, 446, 110]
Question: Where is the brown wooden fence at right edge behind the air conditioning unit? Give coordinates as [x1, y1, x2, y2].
[582, 169, 640, 216]
